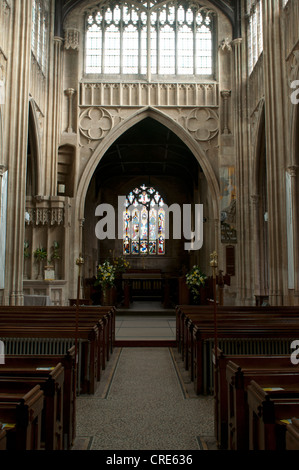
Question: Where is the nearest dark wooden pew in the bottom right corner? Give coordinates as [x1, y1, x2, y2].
[247, 380, 299, 450]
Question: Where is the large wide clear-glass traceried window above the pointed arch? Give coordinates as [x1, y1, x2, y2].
[85, 0, 214, 77]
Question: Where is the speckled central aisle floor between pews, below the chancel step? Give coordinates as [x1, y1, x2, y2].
[75, 347, 214, 450]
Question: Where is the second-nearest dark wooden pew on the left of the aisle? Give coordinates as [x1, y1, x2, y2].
[0, 363, 64, 451]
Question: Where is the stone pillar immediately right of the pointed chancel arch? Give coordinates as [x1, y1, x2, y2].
[232, 38, 254, 305]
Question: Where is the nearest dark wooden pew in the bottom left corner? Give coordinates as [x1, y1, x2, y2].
[0, 385, 44, 450]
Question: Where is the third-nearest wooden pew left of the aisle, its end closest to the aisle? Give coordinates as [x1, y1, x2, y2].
[0, 346, 76, 449]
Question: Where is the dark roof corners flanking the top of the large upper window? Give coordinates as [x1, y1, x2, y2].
[55, 0, 241, 39]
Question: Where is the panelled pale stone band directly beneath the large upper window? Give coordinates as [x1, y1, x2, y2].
[80, 82, 219, 107]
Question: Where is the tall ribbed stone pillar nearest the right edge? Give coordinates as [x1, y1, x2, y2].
[263, 0, 288, 305]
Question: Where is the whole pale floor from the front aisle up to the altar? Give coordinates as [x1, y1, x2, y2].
[74, 302, 217, 451]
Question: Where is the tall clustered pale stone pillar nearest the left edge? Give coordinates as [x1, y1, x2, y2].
[4, 0, 32, 305]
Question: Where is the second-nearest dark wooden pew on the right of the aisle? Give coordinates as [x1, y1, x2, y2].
[226, 356, 299, 450]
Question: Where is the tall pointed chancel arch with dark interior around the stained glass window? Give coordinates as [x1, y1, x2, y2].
[78, 109, 219, 298]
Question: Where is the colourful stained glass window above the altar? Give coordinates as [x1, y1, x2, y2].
[123, 185, 165, 256]
